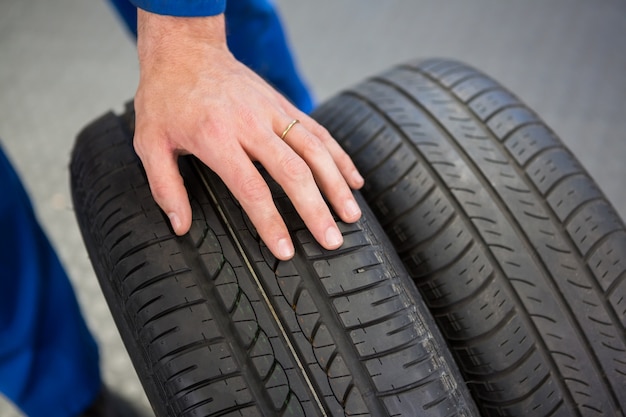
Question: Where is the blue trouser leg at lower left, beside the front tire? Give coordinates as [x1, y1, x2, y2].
[0, 144, 101, 417]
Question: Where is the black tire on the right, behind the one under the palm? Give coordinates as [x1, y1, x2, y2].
[314, 60, 626, 416]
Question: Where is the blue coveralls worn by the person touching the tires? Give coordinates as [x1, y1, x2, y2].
[0, 0, 313, 417]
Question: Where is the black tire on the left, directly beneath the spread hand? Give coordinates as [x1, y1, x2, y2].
[71, 101, 478, 417]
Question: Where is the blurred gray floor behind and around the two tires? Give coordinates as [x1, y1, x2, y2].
[0, 0, 626, 416]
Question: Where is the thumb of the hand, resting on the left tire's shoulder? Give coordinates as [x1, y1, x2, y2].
[135, 140, 191, 236]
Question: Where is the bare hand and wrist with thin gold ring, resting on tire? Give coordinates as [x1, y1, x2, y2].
[134, 10, 363, 260]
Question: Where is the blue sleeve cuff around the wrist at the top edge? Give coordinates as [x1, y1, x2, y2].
[130, 0, 226, 17]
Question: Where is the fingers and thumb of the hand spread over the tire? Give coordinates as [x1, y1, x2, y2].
[135, 112, 363, 260]
